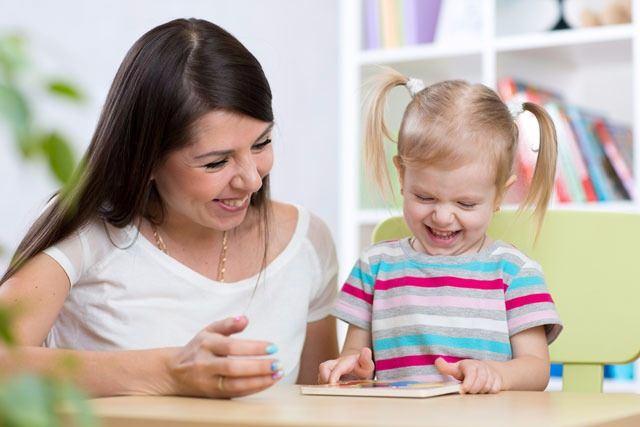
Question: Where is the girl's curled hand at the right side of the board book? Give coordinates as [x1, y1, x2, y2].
[435, 357, 503, 394]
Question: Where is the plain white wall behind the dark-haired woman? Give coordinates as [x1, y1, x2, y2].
[0, 0, 338, 270]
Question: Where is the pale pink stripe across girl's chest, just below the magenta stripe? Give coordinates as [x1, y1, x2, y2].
[373, 295, 504, 310]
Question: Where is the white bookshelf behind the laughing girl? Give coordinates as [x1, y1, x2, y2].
[337, 0, 640, 392]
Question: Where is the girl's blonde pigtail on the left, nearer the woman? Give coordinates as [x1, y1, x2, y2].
[364, 67, 409, 198]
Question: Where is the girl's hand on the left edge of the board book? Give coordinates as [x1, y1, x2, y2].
[318, 347, 376, 384]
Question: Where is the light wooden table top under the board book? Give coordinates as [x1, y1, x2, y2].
[91, 385, 640, 427]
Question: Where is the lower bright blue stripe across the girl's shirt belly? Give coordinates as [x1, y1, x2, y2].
[373, 334, 511, 356]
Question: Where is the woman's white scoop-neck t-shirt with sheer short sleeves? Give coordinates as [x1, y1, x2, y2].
[44, 207, 337, 382]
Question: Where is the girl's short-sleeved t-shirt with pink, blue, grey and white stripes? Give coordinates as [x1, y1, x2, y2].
[333, 238, 562, 382]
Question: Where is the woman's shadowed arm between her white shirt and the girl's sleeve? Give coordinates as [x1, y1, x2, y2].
[297, 316, 338, 384]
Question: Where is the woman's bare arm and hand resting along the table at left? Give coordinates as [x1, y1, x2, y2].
[0, 254, 281, 397]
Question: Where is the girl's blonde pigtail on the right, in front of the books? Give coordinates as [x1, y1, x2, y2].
[521, 102, 558, 238]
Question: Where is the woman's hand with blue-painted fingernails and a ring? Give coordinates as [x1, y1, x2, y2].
[167, 316, 283, 398]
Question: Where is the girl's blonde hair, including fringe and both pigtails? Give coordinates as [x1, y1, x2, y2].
[364, 68, 557, 235]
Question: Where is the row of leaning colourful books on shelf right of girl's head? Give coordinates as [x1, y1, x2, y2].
[498, 78, 635, 203]
